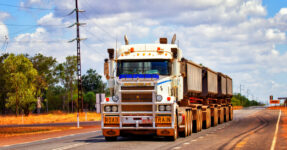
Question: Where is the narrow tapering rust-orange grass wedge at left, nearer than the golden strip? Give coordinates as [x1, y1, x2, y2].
[0, 127, 75, 138]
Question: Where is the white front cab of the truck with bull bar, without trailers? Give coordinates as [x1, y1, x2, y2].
[101, 39, 183, 140]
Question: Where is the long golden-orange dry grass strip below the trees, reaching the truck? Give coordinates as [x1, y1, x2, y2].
[0, 112, 101, 125]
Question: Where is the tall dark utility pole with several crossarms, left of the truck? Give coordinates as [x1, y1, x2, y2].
[69, 0, 84, 128]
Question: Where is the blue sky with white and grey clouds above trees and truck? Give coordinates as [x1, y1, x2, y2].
[0, 0, 287, 103]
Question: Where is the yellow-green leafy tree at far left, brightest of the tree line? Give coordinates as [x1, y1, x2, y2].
[3, 54, 38, 116]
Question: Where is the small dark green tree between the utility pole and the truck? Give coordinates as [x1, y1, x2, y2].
[82, 69, 105, 93]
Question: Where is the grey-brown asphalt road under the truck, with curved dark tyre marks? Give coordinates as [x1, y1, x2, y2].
[2, 107, 279, 150]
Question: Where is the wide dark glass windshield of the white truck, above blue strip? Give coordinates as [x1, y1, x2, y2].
[117, 60, 171, 76]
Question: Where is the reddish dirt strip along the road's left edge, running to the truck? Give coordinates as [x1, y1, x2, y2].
[0, 126, 100, 147]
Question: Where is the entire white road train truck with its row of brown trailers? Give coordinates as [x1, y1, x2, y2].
[101, 35, 233, 141]
